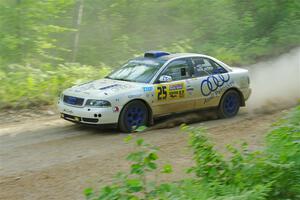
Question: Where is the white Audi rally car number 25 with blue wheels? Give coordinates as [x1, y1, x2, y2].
[58, 51, 251, 132]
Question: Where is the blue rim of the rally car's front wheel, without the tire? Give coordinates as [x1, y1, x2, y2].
[125, 106, 147, 129]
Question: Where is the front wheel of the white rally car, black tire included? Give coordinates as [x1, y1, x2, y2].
[119, 100, 149, 133]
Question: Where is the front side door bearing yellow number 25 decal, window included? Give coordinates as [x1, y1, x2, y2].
[152, 58, 195, 116]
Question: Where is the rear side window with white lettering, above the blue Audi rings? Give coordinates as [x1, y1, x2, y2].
[192, 57, 227, 77]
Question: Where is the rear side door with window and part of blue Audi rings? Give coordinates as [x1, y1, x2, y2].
[191, 57, 231, 109]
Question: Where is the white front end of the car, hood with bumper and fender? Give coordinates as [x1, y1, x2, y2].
[58, 79, 151, 124]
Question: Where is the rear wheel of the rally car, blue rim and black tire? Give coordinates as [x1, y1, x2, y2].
[218, 90, 241, 118]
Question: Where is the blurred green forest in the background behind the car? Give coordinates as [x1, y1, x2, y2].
[0, 0, 300, 107]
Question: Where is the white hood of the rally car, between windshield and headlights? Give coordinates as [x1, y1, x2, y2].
[64, 79, 147, 98]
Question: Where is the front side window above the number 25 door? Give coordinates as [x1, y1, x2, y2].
[161, 59, 191, 81]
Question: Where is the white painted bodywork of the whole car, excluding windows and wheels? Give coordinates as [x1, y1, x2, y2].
[58, 54, 251, 124]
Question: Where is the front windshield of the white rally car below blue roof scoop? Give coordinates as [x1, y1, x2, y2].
[106, 59, 164, 83]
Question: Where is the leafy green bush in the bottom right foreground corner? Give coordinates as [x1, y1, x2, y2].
[178, 106, 300, 199]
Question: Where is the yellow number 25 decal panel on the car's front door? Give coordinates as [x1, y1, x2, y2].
[155, 82, 186, 101]
